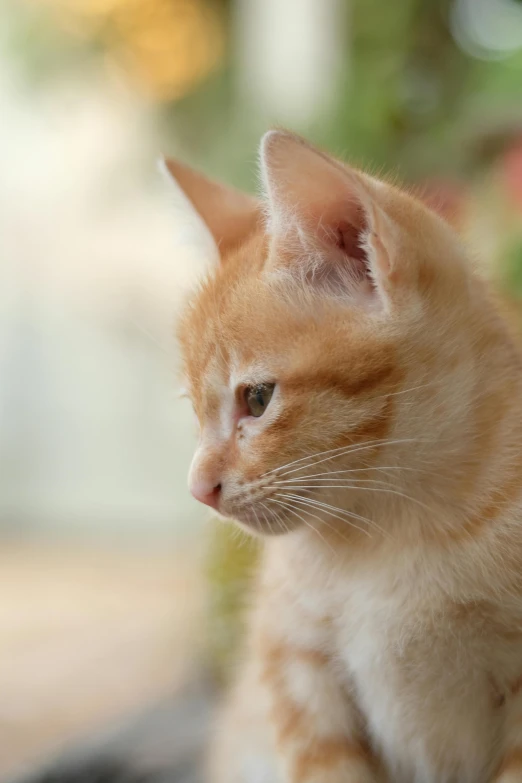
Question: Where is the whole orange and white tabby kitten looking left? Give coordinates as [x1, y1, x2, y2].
[167, 131, 522, 783]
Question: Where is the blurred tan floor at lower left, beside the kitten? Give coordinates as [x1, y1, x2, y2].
[0, 542, 202, 781]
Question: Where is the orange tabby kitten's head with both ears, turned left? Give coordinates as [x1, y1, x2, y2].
[167, 131, 498, 534]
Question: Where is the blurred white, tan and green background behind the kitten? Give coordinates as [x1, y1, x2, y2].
[0, 0, 522, 780]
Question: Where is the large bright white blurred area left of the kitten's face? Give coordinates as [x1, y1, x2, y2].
[0, 60, 206, 535]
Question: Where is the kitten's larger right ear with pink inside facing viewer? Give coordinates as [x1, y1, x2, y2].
[261, 131, 396, 309]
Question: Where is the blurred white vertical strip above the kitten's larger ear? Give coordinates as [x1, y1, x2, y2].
[234, 0, 349, 127]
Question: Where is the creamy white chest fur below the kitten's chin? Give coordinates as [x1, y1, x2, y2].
[265, 540, 506, 783]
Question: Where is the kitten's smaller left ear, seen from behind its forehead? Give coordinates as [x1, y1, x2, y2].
[159, 158, 262, 259]
